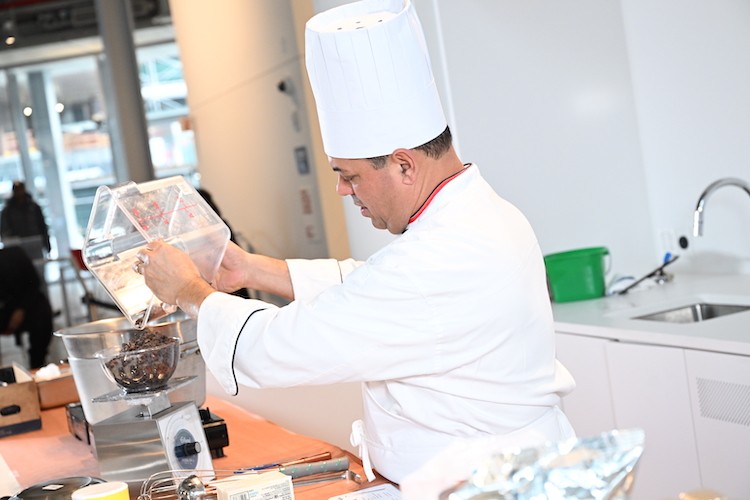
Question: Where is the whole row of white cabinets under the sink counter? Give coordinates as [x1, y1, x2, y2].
[556, 332, 750, 500]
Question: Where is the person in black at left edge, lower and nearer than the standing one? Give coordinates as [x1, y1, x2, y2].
[0, 246, 53, 369]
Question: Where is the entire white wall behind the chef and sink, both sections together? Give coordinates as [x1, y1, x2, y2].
[338, 0, 750, 275]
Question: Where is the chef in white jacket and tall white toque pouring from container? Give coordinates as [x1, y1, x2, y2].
[137, 0, 574, 483]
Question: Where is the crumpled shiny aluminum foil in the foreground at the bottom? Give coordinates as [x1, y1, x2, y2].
[440, 429, 645, 500]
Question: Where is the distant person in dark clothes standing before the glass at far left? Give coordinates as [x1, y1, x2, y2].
[0, 181, 50, 258]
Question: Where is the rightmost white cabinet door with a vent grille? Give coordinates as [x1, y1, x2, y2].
[685, 351, 750, 499]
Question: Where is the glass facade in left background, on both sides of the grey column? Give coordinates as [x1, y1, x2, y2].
[0, 42, 199, 336]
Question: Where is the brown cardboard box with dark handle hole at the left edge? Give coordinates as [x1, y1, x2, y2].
[0, 363, 42, 437]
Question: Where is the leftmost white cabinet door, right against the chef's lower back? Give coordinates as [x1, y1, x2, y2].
[556, 333, 615, 437]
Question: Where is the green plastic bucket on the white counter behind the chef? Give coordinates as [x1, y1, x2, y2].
[544, 247, 609, 302]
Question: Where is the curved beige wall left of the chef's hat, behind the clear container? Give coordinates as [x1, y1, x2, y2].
[171, 0, 327, 257]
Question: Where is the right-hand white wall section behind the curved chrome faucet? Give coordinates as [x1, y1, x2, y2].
[622, 0, 750, 274]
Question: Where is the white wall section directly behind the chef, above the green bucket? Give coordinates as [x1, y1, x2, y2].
[436, 0, 656, 273]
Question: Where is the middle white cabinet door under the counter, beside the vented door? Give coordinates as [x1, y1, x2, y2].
[606, 342, 701, 499]
